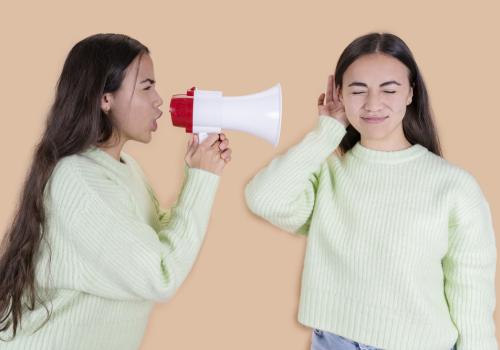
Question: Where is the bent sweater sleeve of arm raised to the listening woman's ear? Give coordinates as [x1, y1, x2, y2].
[245, 116, 346, 234]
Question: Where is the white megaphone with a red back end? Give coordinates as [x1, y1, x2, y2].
[170, 84, 281, 146]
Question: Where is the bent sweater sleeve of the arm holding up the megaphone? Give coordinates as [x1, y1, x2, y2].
[51, 160, 219, 302]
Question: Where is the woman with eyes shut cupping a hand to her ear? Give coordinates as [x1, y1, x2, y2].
[245, 33, 498, 350]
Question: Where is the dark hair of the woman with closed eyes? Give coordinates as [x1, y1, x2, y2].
[335, 33, 442, 156]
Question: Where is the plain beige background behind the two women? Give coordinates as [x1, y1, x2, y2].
[0, 0, 500, 350]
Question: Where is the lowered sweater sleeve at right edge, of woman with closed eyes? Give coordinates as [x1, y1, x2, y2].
[443, 191, 498, 350]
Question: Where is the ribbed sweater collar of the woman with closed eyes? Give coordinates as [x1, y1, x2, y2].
[350, 141, 427, 164]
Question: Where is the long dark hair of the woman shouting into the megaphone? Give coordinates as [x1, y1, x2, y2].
[0, 34, 149, 337]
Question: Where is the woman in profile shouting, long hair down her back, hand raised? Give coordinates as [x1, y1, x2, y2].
[0, 34, 231, 350]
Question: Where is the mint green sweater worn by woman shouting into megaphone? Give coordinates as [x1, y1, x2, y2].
[0, 147, 219, 350]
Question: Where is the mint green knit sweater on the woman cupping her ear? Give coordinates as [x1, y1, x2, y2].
[245, 116, 498, 350]
